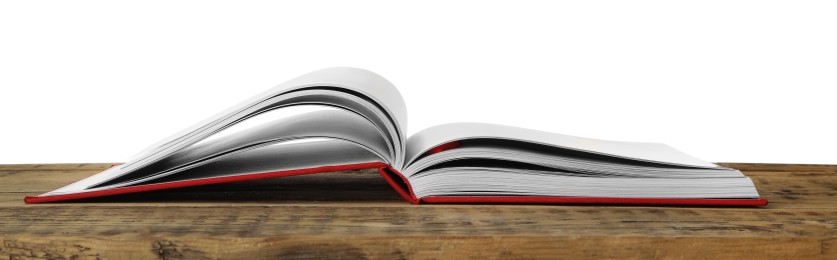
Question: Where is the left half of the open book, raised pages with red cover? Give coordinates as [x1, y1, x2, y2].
[25, 68, 406, 203]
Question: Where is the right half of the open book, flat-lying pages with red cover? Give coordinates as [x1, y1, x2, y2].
[394, 123, 767, 206]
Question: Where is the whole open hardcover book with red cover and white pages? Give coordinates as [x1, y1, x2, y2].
[25, 68, 767, 206]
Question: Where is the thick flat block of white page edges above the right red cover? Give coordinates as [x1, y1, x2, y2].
[409, 167, 759, 199]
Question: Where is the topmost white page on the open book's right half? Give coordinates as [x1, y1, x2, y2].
[406, 123, 719, 168]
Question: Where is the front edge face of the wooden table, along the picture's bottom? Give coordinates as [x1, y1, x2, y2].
[0, 236, 837, 259]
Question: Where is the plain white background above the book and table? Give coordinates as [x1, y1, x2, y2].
[0, 0, 837, 164]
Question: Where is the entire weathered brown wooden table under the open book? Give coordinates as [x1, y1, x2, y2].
[0, 163, 837, 259]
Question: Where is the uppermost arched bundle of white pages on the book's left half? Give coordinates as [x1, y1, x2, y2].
[44, 68, 407, 195]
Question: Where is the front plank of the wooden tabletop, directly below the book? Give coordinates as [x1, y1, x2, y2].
[0, 203, 837, 238]
